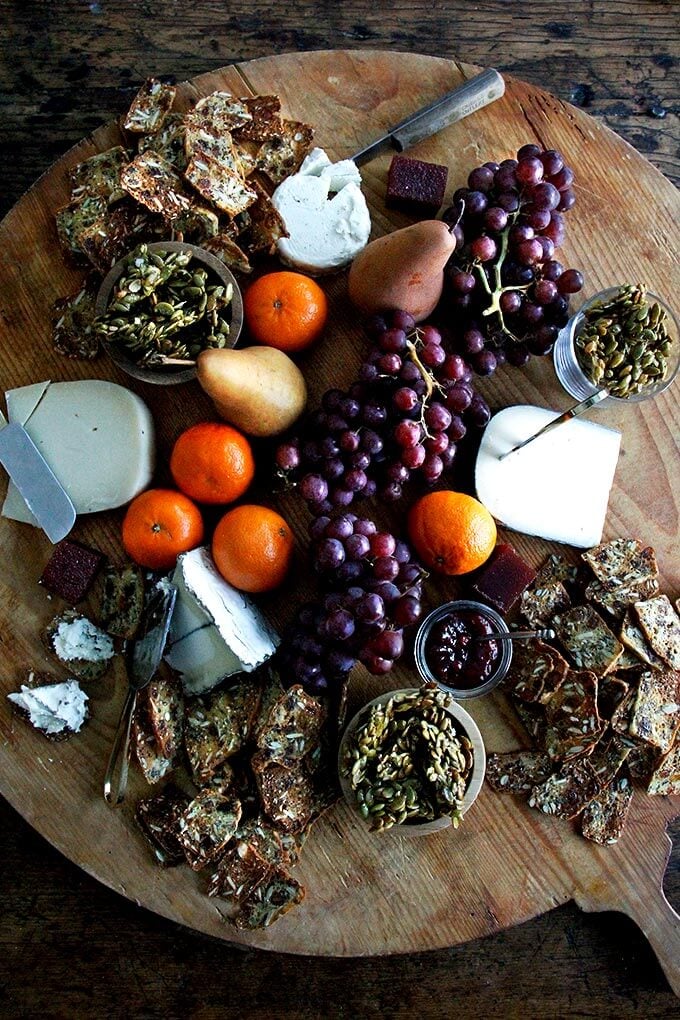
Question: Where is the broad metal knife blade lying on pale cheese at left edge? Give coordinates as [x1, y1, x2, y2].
[0, 412, 75, 544]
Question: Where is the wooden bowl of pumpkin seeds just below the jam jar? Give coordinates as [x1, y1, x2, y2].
[338, 683, 486, 836]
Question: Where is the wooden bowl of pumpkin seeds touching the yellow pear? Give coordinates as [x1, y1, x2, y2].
[94, 241, 244, 386]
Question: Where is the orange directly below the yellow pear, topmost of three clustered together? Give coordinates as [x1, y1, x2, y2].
[170, 421, 255, 503]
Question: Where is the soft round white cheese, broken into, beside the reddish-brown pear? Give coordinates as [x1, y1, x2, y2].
[271, 149, 371, 275]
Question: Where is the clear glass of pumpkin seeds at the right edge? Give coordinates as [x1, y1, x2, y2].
[554, 284, 680, 403]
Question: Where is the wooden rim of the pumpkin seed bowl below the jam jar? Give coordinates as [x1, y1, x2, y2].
[337, 687, 486, 837]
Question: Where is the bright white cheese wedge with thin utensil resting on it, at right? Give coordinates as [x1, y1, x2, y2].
[475, 405, 621, 549]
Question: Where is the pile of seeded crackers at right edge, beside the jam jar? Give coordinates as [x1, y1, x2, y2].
[486, 539, 680, 845]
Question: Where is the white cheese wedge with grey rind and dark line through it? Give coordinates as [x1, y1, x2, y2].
[165, 547, 279, 695]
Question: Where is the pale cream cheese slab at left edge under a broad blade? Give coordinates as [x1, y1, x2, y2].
[2, 379, 154, 526]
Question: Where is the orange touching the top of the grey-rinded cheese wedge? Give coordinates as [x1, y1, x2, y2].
[212, 504, 293, 592]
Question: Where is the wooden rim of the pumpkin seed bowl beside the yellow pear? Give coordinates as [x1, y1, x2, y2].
[95, 241, 244, 386]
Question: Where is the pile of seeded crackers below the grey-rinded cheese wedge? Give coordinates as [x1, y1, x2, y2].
[133, 672, 337, 929]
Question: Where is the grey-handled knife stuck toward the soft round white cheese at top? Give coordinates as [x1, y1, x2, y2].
[350, 67, 506, 166]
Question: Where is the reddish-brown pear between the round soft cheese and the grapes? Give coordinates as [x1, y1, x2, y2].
[349, 219, 456, 322]
